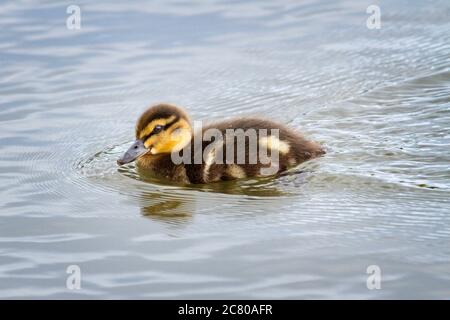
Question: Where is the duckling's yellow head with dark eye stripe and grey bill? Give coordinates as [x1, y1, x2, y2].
[117, 104, 192, 165]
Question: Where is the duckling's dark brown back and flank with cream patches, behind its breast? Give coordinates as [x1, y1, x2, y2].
[184, 118, 325, 183]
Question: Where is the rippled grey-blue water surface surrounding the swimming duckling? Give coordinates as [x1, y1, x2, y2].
[0, 0, 450, 299]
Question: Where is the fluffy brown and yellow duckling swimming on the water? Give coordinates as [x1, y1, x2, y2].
[117, 104, 325, 184]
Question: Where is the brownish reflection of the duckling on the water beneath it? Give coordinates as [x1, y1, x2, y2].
[137, 164, 314, 229]
